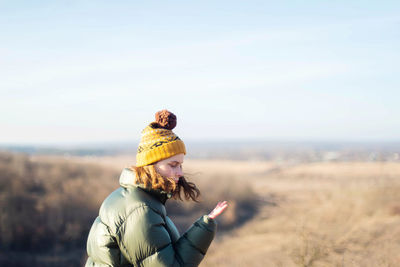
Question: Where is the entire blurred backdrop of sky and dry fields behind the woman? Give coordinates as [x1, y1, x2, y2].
[0, 0, 400, 266]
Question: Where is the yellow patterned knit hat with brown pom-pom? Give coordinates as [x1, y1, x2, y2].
[136, 109, 186, 167]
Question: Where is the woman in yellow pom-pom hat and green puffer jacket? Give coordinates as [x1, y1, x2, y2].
[86, 110, 227, 266]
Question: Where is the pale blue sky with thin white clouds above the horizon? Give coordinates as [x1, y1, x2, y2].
[0, 0, 400, 145]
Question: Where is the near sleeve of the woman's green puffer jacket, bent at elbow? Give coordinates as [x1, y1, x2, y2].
[117, 206, 216, 267]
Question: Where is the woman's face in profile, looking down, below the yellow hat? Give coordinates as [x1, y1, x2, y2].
[154, 153, 185, 183]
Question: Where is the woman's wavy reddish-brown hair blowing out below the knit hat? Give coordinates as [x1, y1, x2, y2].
[130, 164, 200, 202]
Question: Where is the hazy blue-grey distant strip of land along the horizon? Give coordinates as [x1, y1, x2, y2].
[0, 140, 400, 162]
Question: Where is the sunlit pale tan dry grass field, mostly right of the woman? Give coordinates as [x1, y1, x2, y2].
[57, 156, 400, 267]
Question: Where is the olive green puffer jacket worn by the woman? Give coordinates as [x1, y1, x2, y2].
[85, 169, 216, 267]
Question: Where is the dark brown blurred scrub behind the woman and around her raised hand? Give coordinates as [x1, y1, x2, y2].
[0, 153, 257, 266]
